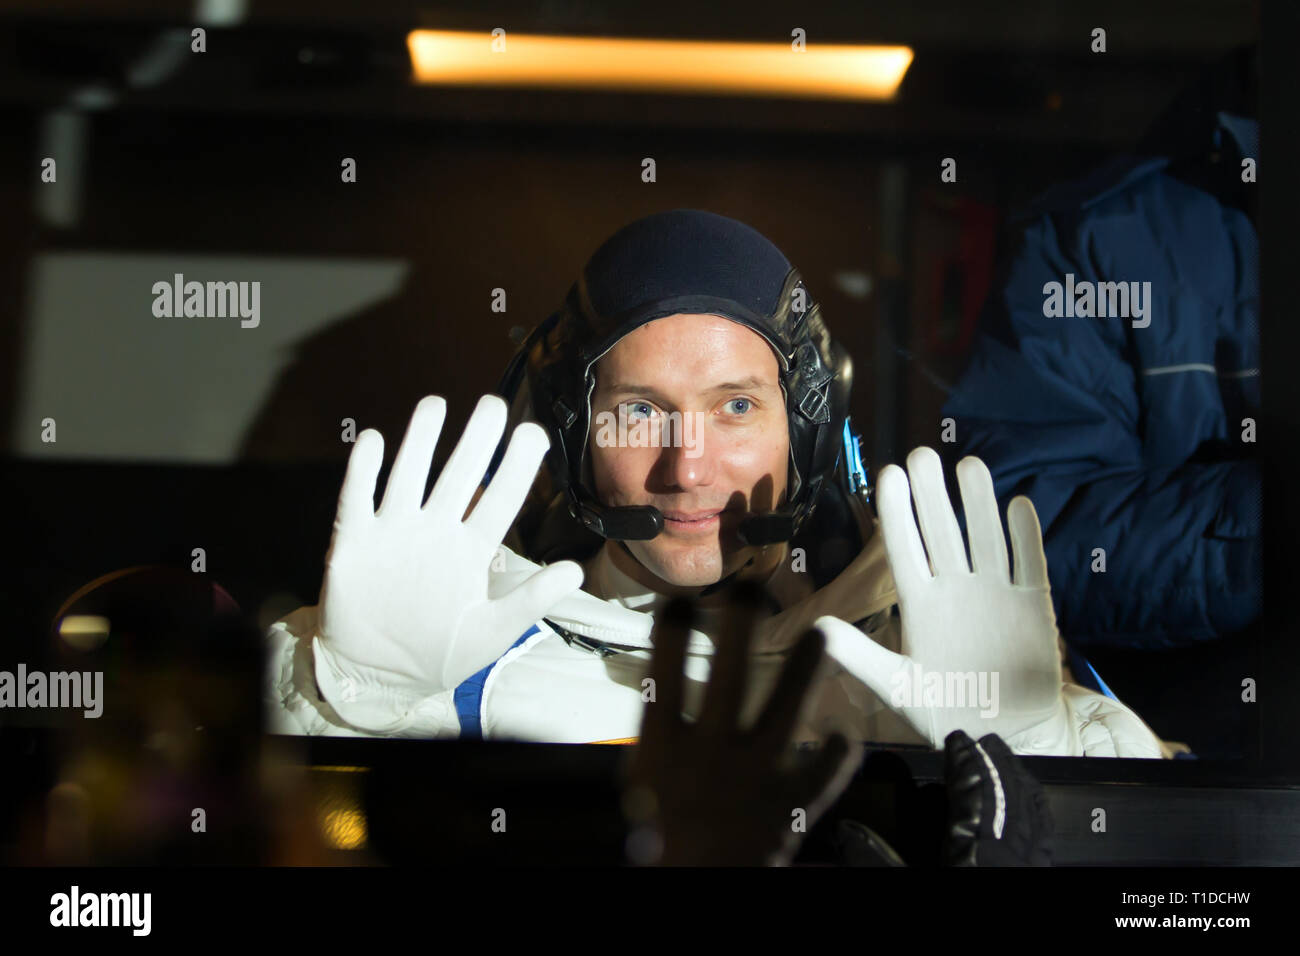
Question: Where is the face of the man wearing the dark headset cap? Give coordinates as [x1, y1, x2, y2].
[588, 313, 790, 591]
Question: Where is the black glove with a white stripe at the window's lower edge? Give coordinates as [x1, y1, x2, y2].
[944, 730, 1053, 866]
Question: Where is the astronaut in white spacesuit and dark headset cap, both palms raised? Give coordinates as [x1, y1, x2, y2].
[265, 209, 1170, 758]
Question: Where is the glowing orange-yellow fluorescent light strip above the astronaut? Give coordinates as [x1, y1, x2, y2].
[407, 30, 913, 100]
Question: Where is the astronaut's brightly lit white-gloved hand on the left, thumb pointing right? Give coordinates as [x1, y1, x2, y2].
[315, 395, 582, 732]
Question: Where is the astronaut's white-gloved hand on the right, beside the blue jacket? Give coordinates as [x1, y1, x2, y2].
[816, 447, 1079, 753]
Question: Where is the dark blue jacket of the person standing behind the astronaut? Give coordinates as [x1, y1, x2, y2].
[944, 113, 1268, 648]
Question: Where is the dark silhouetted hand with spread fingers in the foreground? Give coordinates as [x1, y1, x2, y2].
[623, 585, 862, 866]
